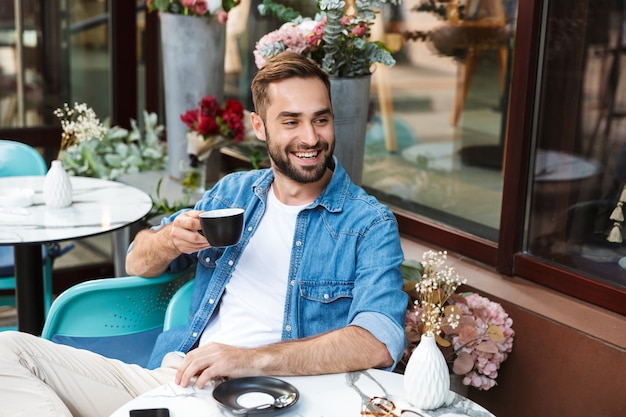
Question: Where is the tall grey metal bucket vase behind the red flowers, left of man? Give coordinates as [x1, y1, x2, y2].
[161, 13, 226, 179]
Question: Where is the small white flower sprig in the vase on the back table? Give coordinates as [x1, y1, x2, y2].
[53, 103, 107, 159]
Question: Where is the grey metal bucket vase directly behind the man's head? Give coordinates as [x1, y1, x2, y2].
[330, 75, 372, 185]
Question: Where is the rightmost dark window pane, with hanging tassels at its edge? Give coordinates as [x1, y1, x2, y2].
[527, 0, 626, 288]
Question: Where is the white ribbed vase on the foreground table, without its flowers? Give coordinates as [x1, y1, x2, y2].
[404, 335, 450, 410]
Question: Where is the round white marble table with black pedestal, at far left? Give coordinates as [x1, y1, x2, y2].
[0, 176, 152, 335]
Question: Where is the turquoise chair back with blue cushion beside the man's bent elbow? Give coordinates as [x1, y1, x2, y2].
[41, 266, 195, 366]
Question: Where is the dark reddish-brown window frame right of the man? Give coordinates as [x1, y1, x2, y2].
[392, 0, 626, 315]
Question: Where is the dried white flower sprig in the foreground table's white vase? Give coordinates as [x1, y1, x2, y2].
[415, 251, 466, 336]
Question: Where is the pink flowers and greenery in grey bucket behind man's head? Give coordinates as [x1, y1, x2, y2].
[254, 0, 400, 184]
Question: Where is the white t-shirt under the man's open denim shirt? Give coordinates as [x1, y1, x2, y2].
[200, 188, 306, 347]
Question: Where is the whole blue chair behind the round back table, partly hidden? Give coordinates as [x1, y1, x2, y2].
[0, 140, 73, 331]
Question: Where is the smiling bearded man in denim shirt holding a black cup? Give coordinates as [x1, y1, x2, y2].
[0, 52, 407, 416]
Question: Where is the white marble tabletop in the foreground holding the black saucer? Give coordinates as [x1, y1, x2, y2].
[110, 369, 494, 417]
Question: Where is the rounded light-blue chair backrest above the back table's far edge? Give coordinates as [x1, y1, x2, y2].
[0, 139, 48, 177]
